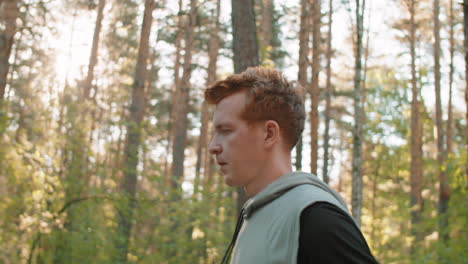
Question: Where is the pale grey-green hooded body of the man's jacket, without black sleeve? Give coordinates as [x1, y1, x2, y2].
[231, 172, 349, 264]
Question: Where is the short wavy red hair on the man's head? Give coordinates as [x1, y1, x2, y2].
[205, 67, 305, 149]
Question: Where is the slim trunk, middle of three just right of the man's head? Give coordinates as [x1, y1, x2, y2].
[310, 0, 322, 174]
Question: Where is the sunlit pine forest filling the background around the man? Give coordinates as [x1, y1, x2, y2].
[0, 0, 468, 264]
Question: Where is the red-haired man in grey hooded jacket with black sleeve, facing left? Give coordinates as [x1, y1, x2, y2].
[205, 67, 377, 264]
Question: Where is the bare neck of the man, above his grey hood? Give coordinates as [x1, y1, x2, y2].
[244, 153, 292, 198]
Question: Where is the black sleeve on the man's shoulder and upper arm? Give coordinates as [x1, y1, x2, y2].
[297, 202, 378, 264]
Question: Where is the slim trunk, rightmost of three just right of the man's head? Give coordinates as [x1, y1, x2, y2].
[322, 0, 333, 183]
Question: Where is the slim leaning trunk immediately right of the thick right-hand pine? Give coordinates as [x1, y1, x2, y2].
[434, 0, 450, 242]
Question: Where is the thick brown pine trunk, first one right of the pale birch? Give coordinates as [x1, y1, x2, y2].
[407, 0, 423, 252]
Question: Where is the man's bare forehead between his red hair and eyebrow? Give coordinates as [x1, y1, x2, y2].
[213, 91, 247, 125]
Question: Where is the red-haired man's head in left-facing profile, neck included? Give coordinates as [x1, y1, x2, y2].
[205, 67, 305, 195]
